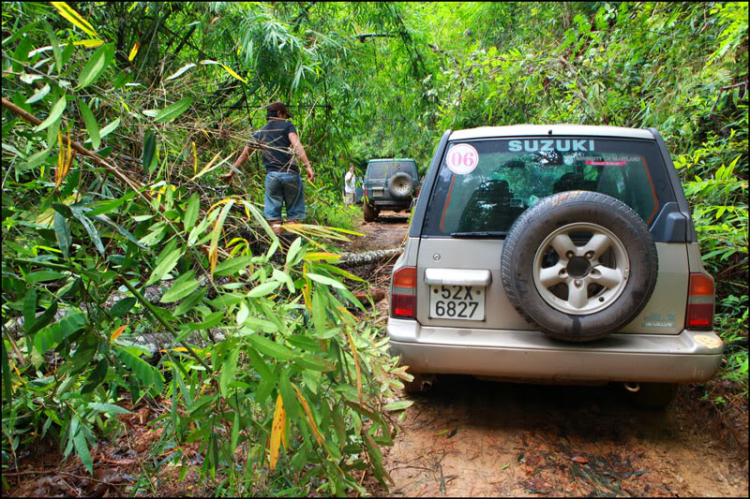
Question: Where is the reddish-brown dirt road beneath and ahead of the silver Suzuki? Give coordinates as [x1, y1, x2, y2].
[351, 214, 748, 497]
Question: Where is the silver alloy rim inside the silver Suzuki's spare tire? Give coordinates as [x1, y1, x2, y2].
[534, 223, 630, 315]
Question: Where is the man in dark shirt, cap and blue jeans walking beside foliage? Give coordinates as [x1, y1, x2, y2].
[223, 102, 315, 234]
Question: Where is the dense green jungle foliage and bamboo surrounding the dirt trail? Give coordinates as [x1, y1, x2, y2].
[2, 2, 748, 495]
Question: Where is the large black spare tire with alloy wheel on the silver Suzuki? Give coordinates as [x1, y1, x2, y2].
[501, 191, 659, 342]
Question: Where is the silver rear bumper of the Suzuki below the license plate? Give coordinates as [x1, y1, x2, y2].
[388, 318, 724, 383]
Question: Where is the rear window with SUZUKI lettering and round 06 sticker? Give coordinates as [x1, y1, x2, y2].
[423, 137, 674, 236]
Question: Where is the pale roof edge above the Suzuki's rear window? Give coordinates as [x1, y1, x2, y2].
[450, 124, 654, 140]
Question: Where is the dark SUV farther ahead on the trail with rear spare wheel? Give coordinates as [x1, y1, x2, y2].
[362, 159, 420, 222]
